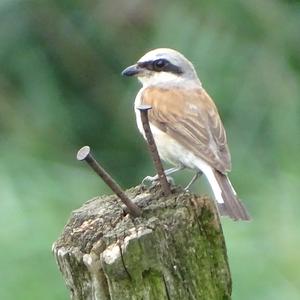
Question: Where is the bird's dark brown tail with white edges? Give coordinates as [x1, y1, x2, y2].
[207, 169, 251, 220]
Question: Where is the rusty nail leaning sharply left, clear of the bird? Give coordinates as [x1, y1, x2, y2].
[77, 146, 142, 217]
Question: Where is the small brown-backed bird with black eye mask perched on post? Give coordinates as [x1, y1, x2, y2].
[122, 48, 251, 220]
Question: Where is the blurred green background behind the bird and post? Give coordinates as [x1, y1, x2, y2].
[0, 0, 300, 300]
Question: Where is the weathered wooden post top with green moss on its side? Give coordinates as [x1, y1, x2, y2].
[53, 186, 231, 300]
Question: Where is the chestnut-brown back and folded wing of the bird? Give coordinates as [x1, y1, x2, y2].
[142, 87, 231, 173]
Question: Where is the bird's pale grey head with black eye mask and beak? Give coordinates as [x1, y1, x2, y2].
[122, 48, 199, 86]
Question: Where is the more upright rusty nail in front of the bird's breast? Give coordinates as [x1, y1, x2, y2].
[137, 105, 171, 196]
